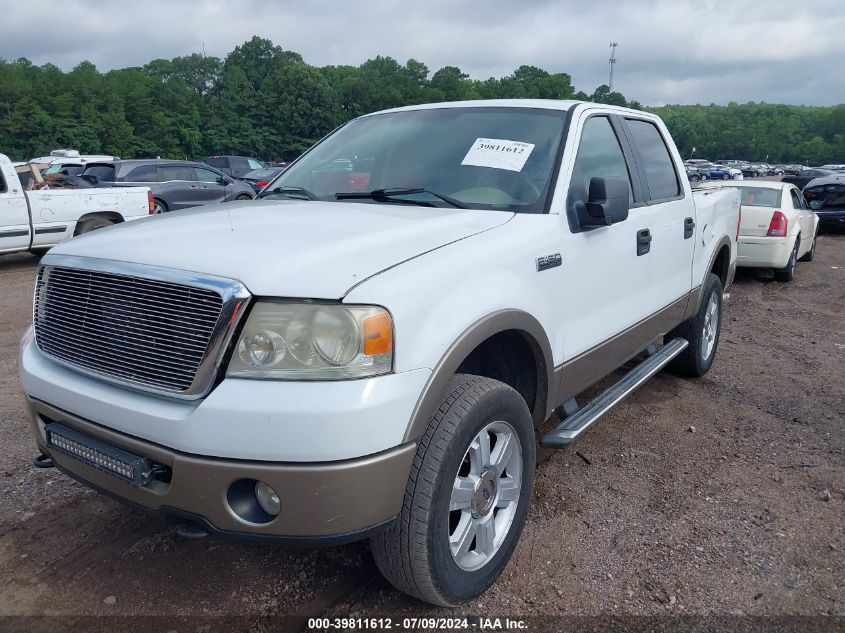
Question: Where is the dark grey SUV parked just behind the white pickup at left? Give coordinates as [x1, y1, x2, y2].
[80, 159, 255, 213]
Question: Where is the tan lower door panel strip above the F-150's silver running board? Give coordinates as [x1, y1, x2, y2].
[555, 295, 692, 403]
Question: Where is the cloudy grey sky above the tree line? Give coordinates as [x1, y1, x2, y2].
[0, 0, 845, 105]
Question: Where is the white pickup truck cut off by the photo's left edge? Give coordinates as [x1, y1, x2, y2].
[0, 154, 153, 253]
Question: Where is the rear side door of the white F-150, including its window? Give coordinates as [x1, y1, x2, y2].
[625, 117, 703, 314]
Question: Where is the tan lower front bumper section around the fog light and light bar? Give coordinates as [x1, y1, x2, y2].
[29, 399, 416, 538]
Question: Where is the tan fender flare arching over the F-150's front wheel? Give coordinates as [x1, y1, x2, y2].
[403, 309, 555, 442]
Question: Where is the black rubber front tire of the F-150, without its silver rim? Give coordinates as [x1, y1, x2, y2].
[370, 374, 536, 606]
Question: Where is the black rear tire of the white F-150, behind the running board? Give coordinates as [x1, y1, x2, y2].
[664, 273, 723, 378]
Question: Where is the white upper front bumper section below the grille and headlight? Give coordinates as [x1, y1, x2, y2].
[20, 333, 431, 462]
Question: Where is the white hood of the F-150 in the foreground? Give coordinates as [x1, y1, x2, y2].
[51, 200, 513, 299]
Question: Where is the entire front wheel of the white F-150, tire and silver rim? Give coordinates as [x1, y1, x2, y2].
[371, 375, 536, 606]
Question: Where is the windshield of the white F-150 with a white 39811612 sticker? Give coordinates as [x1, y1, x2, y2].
[262, 107, 566, 213]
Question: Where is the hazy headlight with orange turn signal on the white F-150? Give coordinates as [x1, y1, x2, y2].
[226, 301, 393, 380]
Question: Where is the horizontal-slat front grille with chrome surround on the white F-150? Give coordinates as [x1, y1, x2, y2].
[33, 258, 251, 396]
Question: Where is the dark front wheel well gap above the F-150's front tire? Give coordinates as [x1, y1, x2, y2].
[455, 330, 548, 425]
